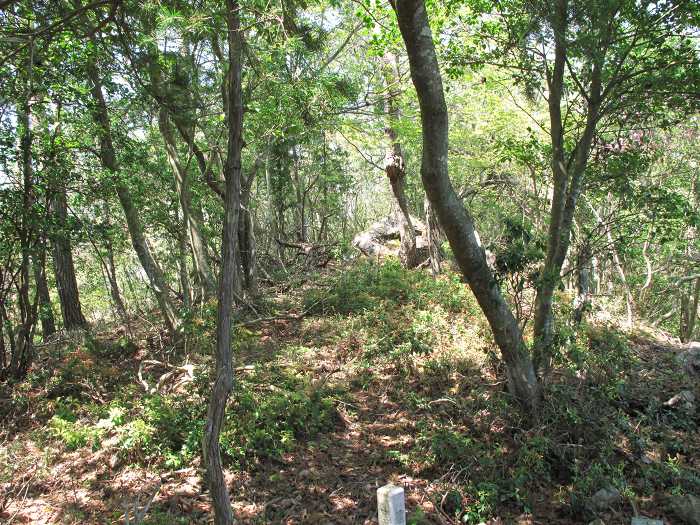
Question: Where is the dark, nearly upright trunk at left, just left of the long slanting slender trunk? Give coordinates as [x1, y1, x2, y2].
[52, 188, 87, 330]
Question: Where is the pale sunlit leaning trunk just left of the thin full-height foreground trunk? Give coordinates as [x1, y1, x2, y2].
[158, 107, 216, 296]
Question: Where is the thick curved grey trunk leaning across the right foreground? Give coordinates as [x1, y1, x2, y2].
[392, 0, 540, 414]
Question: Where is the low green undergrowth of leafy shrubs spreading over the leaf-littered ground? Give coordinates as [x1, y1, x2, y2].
[0, 261, 700, 523]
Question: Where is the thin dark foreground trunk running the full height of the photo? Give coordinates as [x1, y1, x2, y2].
[202, 0, 243, 525]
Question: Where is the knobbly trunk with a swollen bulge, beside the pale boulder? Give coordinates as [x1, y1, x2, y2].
[384, 53, 419, 268]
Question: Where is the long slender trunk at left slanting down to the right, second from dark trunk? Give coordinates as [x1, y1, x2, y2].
[87, 59, 179, 334]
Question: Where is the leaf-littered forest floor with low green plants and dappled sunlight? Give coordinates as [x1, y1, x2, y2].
[0, 263, 700, 525]
